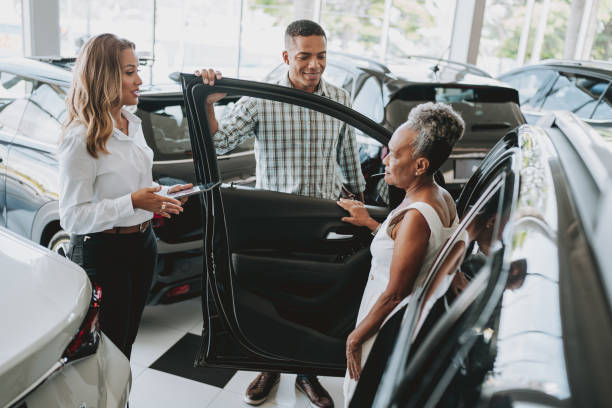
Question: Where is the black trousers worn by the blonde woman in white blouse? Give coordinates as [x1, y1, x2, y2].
[69, 225, 157, 359]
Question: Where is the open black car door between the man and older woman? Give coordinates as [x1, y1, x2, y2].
[181, 74, 398, 376]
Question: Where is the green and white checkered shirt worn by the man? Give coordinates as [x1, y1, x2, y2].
[213, 76, 365, 200]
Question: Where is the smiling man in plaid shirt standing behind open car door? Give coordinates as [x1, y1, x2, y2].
[196, 20, 365, 201]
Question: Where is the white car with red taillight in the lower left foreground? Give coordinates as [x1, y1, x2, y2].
[0, 228, 132, 408]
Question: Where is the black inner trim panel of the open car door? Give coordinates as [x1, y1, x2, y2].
[222, 188, 388, 350]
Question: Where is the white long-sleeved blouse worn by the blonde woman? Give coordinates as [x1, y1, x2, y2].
[58, 108, 161, 234]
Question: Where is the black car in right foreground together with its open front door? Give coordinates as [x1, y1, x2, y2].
[182, 75, 612, 407]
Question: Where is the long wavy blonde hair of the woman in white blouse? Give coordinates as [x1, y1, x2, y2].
[64, 34, 136, 158]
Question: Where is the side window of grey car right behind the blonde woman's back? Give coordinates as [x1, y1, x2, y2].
[18, 84, 66, 145]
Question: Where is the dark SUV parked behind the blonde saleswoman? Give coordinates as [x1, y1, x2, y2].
[0, 58, 208, 303]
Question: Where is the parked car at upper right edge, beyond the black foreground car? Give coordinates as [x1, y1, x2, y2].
[499, 60, 612, 138]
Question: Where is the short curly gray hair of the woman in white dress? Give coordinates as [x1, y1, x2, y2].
[404, 102, 465, 175]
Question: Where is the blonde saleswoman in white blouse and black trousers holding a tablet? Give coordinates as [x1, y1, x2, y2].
[59, 34, 191, 359]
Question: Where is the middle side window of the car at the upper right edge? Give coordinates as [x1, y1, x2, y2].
[542, 73, 607, 118]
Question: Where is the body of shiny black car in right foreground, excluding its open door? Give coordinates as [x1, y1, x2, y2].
[370, 113, 612, 407]
